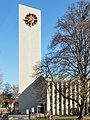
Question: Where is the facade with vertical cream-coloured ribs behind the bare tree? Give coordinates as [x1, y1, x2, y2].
[47, 81, 90, 115]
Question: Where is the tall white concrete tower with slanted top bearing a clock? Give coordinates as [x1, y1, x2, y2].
[19, 4, 41, 94]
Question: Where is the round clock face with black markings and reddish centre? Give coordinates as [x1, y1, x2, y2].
[23, 13, 38, 27]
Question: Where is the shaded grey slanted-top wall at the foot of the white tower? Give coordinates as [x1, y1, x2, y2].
[19, 77, 47, 113]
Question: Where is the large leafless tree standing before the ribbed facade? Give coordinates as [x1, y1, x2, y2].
[35, 1, 90, 120]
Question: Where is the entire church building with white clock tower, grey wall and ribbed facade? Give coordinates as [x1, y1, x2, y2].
[19, 4, 90, 115]
